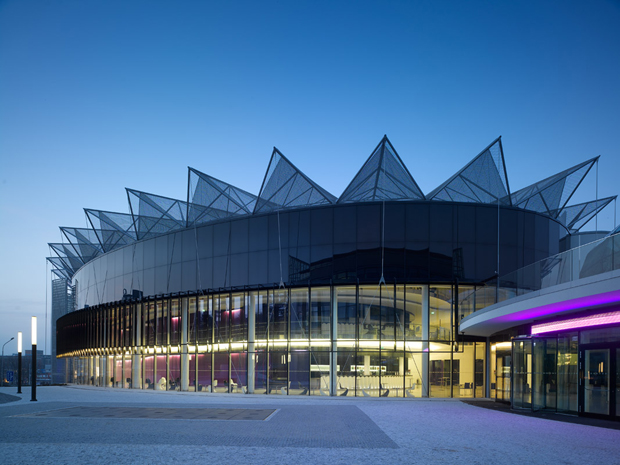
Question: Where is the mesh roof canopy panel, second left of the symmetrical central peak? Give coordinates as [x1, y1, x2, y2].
[187, 168, 256, 225]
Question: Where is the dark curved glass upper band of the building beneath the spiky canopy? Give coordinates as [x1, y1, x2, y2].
[73, 201, 565, 308]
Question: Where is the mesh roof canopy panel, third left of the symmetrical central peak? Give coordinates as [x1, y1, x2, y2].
[127, 189, 188, 239]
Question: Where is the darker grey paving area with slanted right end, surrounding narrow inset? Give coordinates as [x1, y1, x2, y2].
[0, 402, 398, 449]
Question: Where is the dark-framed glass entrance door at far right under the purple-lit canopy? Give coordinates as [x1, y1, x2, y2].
[582, 349, 615, 415]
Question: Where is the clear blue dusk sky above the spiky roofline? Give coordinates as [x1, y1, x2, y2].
[0, 0, 620, 354]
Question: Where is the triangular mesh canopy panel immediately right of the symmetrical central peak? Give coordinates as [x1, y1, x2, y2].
[426, 137, 510, 205]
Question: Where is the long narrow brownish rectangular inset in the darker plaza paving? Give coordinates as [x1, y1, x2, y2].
[17, 407, 276, 421]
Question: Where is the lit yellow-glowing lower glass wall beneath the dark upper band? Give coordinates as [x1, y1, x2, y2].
[60, 284, 484, 396]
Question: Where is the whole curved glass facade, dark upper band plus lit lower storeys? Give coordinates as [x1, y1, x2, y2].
[57, 201, 564, 397]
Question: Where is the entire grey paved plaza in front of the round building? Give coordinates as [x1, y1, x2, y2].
[0, 386, 620, 465]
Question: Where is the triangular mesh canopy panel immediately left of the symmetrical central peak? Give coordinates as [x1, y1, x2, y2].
[254, 147, 336, 213]
